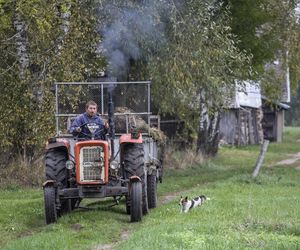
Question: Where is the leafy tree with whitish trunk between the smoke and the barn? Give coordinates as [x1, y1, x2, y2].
[149, 0, 250, 155]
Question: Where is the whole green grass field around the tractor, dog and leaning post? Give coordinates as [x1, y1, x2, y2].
[0, 128, 300, 249]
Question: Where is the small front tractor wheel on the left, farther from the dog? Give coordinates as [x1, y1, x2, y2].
[44, 187, 57, 224]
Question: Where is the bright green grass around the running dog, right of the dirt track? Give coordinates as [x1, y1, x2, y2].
[118, 169, 300, 249]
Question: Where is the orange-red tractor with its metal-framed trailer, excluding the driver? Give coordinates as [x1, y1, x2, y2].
[43, 82, 162, 224]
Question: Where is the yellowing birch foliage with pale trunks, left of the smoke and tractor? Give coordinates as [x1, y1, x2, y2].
[0, 0, 104, 162]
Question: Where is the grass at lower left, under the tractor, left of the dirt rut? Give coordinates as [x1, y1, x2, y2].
[0, 189, 135, 249]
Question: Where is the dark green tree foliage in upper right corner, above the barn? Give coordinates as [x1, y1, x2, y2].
[219, 0, 300, 100]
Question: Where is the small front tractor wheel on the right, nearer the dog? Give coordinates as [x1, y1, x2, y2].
[130, 181, 143, 222]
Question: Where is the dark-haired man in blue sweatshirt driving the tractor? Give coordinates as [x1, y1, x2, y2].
[70, 101, 109, 140]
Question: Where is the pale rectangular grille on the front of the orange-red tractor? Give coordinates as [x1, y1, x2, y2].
[80, 146, 104, 182]
